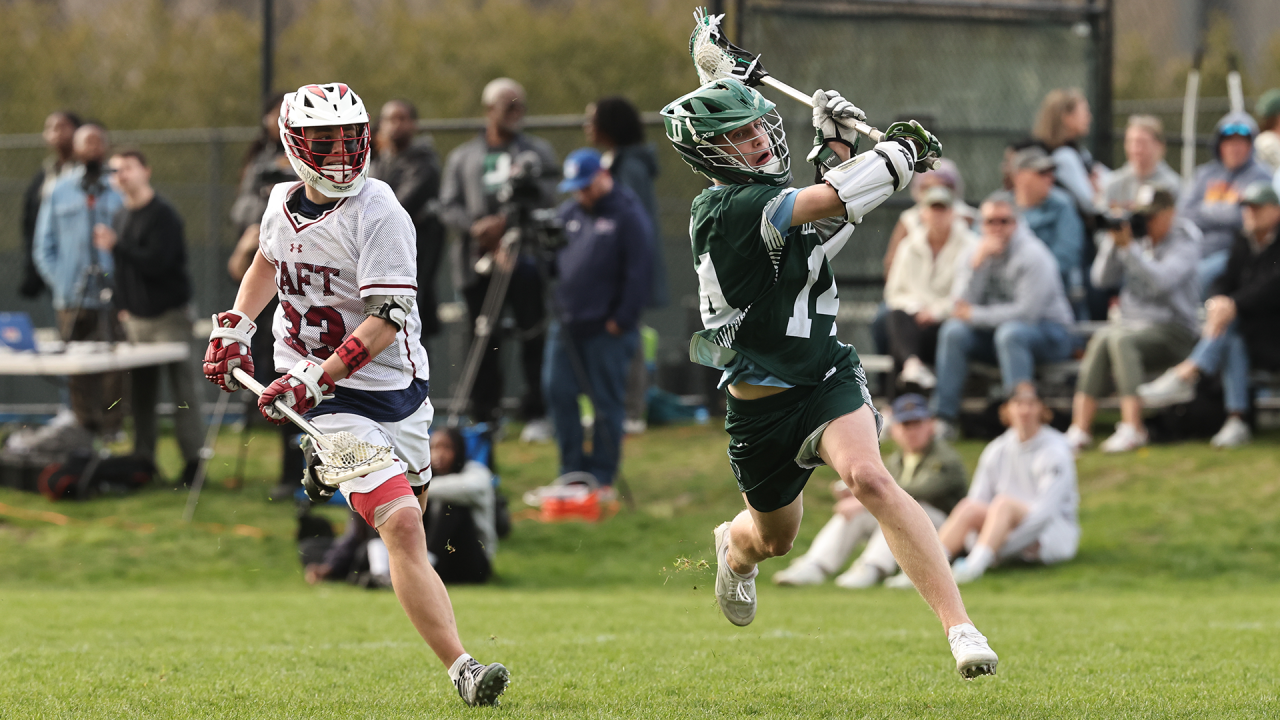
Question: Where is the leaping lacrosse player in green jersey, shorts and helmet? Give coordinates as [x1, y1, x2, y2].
[662, 78, 997, 678]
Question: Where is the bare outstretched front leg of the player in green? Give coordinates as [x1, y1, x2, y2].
[818, 406, 969, 630]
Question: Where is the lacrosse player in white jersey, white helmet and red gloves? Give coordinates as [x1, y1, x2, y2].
[205, 83, 508, 705]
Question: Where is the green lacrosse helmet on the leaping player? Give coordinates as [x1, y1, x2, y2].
[662, 78, 791, 187]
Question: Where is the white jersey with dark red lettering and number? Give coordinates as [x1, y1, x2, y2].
[259, 178, 430, 391]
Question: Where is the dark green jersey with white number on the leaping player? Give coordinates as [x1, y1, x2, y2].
[689, 184, 858, 386]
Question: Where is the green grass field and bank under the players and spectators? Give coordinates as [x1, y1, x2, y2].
[0, 417, 1280, 719]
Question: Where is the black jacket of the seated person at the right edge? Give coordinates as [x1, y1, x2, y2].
[1210, 229, 1280, 370]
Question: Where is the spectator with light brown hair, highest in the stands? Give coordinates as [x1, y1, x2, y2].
[1032, 87, 1097, 214]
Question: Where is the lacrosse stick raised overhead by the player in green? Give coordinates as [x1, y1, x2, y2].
[689, 8, 940, 169]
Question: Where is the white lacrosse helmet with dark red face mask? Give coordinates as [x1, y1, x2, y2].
[279, 82, 369, 197]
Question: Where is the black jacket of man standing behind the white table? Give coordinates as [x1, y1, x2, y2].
[111, 195, 191, 318]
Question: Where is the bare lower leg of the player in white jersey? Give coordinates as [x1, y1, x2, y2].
[378, 502, 465, 667]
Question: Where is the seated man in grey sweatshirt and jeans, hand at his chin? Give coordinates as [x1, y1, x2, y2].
[931, 191, 1073, 439]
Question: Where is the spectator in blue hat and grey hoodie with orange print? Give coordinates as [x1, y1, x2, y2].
[1178, 113, 1271, 297]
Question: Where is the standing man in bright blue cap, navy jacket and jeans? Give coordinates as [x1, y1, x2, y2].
[543, 147, 653, 487]
